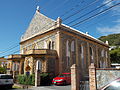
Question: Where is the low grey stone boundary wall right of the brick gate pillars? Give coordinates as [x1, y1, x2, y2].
[96, 68, 120, 89]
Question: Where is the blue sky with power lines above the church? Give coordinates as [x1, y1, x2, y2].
[0, 0, 120, 56]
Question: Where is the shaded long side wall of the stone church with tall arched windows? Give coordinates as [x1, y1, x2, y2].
[61, 30, 109, 77]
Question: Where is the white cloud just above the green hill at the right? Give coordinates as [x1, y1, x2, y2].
[97, 24, 120, 35]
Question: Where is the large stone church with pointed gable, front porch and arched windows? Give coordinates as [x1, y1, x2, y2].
[8, 7, 110, 76]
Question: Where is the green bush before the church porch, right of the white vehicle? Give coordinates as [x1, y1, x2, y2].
[17, 74, 35, 85]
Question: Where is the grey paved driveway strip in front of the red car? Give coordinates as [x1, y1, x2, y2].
[29, 85, 71, 90]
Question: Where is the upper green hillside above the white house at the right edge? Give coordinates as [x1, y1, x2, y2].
[98, 33, 120, 46]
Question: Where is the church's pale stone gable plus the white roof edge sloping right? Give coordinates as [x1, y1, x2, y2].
[21, 10, 108, 46]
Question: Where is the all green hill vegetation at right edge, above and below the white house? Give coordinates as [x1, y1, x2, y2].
[99, 34, 120, 63]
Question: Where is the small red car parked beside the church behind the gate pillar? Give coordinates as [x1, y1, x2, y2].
[52, 73, 71, 85]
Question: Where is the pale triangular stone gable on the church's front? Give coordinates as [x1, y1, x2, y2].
[21, 10, 56, 41]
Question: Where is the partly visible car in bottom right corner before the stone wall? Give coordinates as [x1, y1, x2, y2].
[99, 78, 120, 90]
